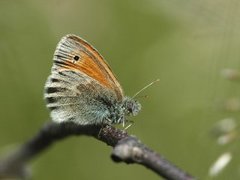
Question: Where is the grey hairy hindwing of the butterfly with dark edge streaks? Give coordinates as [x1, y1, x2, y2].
[45, 71, 116, 125]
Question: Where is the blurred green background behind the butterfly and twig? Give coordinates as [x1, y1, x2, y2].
[0, 0, 240, 180]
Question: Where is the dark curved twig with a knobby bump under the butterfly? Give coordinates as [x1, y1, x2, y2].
[0, 122, 194, 180]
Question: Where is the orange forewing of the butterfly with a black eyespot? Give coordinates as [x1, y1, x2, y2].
[54, 35, 123, 100]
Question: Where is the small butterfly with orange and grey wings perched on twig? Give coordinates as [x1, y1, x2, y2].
[44, 34, 141, 125]
